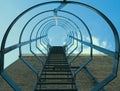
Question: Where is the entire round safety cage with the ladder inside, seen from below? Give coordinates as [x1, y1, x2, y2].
[0, 0, 120, 91]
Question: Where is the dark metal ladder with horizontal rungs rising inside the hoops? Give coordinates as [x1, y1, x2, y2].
[34, 46, 78, 91]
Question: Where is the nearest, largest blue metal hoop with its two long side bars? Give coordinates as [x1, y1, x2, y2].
[0, 0, 120, 91]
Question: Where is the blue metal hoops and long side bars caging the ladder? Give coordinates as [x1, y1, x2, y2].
[0, 0, 120, 91]
